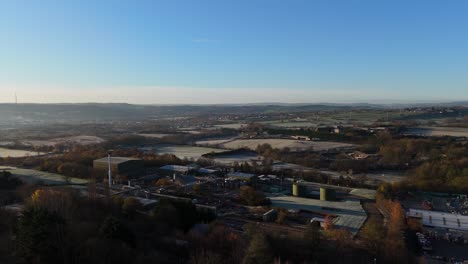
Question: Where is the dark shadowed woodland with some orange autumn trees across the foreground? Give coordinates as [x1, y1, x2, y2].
[0, 175, 413, 264]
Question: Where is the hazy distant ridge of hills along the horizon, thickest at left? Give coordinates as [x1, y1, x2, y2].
[0, 102, 468, 124]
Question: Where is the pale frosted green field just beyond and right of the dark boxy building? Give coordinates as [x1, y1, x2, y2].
[141, 144, 225, 160]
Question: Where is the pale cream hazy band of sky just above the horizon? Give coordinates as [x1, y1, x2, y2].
[0, 87, 467, 105]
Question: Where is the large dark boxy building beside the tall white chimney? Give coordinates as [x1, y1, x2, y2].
[93, 157, 145, 177]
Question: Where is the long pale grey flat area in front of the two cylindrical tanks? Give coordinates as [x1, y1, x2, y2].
[268, 195, 367, 235]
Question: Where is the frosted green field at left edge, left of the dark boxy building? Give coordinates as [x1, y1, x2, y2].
[0, 166, 88, 185]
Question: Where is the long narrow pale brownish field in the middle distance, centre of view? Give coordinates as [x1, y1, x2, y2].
[222, 138, 354, 151]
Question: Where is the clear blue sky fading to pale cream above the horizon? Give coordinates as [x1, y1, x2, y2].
[0, 0, 468, 104]
